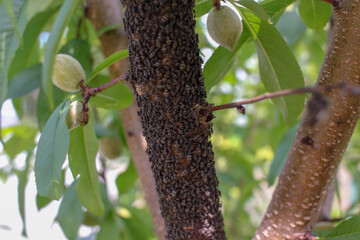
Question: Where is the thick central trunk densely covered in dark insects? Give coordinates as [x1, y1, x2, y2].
[123, 0, 225, 240]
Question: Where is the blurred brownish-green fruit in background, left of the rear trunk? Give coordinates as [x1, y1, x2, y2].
[99, 136, 122, 159]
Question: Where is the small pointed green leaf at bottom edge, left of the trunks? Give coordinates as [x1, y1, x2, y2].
[96, 211, 120, 240]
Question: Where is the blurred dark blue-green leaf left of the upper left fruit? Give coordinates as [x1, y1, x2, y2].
[6, 64, 42, 98]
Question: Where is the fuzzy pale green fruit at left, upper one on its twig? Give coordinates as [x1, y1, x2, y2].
[52, 54, 86, 92]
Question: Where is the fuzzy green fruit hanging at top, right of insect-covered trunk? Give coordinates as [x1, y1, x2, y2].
[206, 6, 242, 51]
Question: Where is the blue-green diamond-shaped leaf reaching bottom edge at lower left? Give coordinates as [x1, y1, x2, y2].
[56, 181, 84, 240]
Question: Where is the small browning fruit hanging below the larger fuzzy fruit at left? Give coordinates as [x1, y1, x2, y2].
[66, 101, 89, 131]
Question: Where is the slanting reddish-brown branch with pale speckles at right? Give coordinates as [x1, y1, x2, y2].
[255, 0, 360, 240]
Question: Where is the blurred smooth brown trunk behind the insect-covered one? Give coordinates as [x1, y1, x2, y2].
[86, 0, 166, 240]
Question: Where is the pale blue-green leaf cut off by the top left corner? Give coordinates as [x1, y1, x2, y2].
[0, 0, 28, 127]
